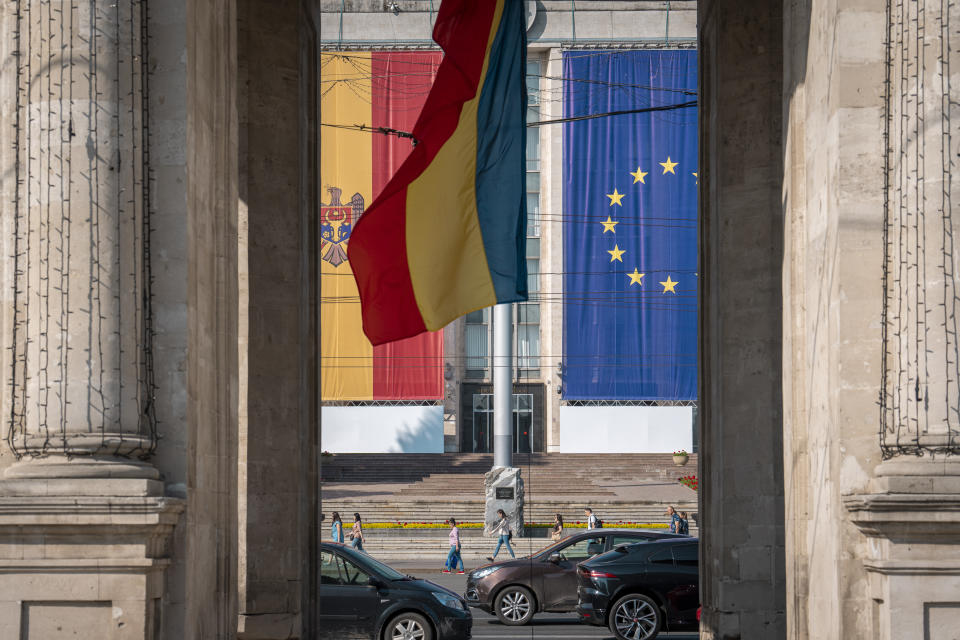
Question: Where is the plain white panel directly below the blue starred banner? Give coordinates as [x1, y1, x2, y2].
[559, 406, 693, 453]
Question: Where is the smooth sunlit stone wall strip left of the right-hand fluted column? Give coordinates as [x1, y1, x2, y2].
[783, 1, 886, 639]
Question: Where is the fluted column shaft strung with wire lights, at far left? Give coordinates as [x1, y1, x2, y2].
[6, 0, 156, 477]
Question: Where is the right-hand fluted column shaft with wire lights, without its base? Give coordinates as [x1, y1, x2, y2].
[881, 0, 960, 457]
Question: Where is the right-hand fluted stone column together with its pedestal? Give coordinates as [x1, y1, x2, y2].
[843, 1, 960, 640]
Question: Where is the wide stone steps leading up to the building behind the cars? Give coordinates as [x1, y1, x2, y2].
[321, 454, 697, 559]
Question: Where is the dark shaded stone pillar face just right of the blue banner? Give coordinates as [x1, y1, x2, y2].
[699, 0, 786, 640]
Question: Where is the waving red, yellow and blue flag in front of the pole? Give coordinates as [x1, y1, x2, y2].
[347, 0, 527, 345]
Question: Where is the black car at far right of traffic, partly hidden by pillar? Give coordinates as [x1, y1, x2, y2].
[577, 538, 700, 640]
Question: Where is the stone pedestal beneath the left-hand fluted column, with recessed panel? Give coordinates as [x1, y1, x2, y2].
[0, 470, 185, 640]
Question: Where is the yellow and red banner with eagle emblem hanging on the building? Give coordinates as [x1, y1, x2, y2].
[319, 51, 443, 401]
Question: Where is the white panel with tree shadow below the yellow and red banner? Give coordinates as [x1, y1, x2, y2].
[320, 406, 443, 453]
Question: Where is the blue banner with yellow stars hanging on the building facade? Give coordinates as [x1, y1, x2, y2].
[563, 50, 698, 400]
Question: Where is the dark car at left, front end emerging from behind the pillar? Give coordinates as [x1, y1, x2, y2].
[320, 542, 473, 640]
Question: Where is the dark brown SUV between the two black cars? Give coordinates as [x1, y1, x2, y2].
[464, 529, 686, 625]
